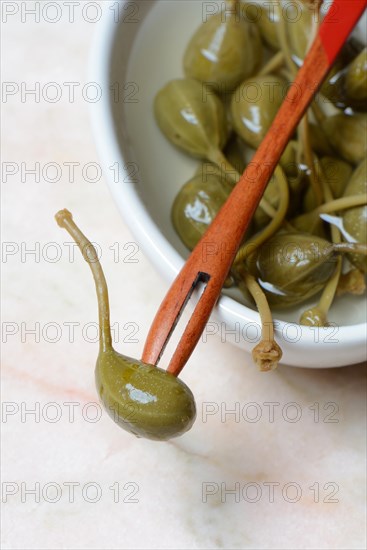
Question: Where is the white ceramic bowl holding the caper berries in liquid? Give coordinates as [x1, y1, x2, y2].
[90, 0, 367, 368]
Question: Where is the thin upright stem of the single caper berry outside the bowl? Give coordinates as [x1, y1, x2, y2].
[55, 209, 112, 352]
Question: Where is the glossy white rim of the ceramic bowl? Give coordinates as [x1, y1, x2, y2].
[88, 0, 367, 367]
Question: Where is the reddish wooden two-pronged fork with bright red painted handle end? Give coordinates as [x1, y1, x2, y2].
[142, 0, 367, 375]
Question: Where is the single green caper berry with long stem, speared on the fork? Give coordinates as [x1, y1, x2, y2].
[56, 210, 196, 440]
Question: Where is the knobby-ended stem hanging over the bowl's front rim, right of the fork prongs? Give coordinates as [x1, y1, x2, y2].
[240, 270, 282, 371]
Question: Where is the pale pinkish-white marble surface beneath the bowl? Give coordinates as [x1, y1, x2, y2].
[1, 1, 366, 550]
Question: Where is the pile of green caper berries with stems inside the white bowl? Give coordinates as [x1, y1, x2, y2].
[154, 0, 367, 340]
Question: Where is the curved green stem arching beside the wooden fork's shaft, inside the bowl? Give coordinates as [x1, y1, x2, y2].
[233, 164, 289, 271]
